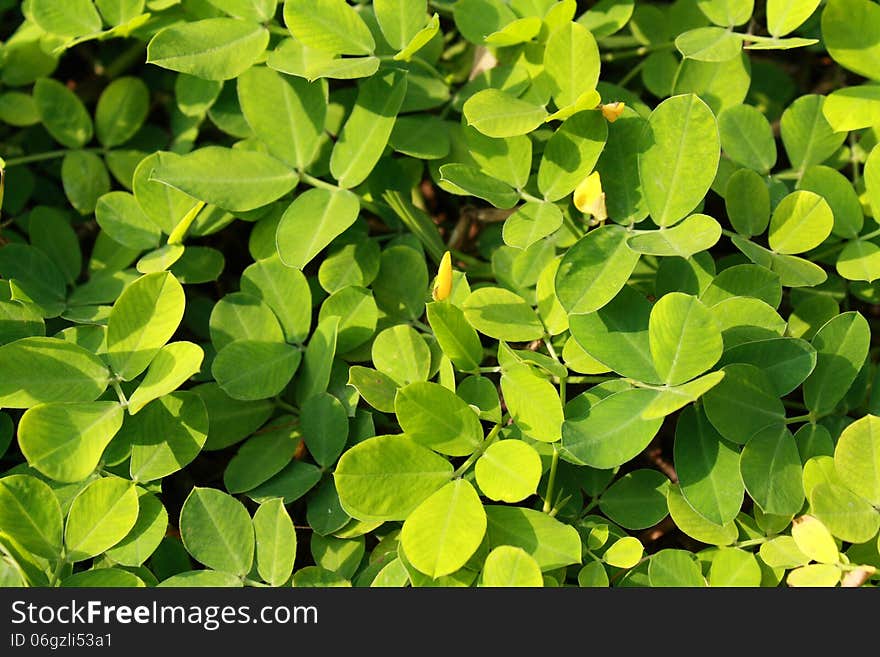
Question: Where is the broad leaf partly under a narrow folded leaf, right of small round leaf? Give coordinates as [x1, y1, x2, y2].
[562, 388, 663, 469]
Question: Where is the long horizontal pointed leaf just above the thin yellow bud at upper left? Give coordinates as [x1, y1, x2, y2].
[151, 146, 299, 212]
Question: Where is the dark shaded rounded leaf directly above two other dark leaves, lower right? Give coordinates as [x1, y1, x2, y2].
[703, 363, 785, 445]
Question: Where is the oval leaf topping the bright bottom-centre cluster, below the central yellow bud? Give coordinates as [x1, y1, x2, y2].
[394, 381, 483, 456]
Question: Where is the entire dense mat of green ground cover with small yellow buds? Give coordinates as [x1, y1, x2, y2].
[0, 0, 880, 587]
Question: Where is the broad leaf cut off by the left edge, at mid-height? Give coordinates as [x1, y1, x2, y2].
[0, 336, 110, 408]
